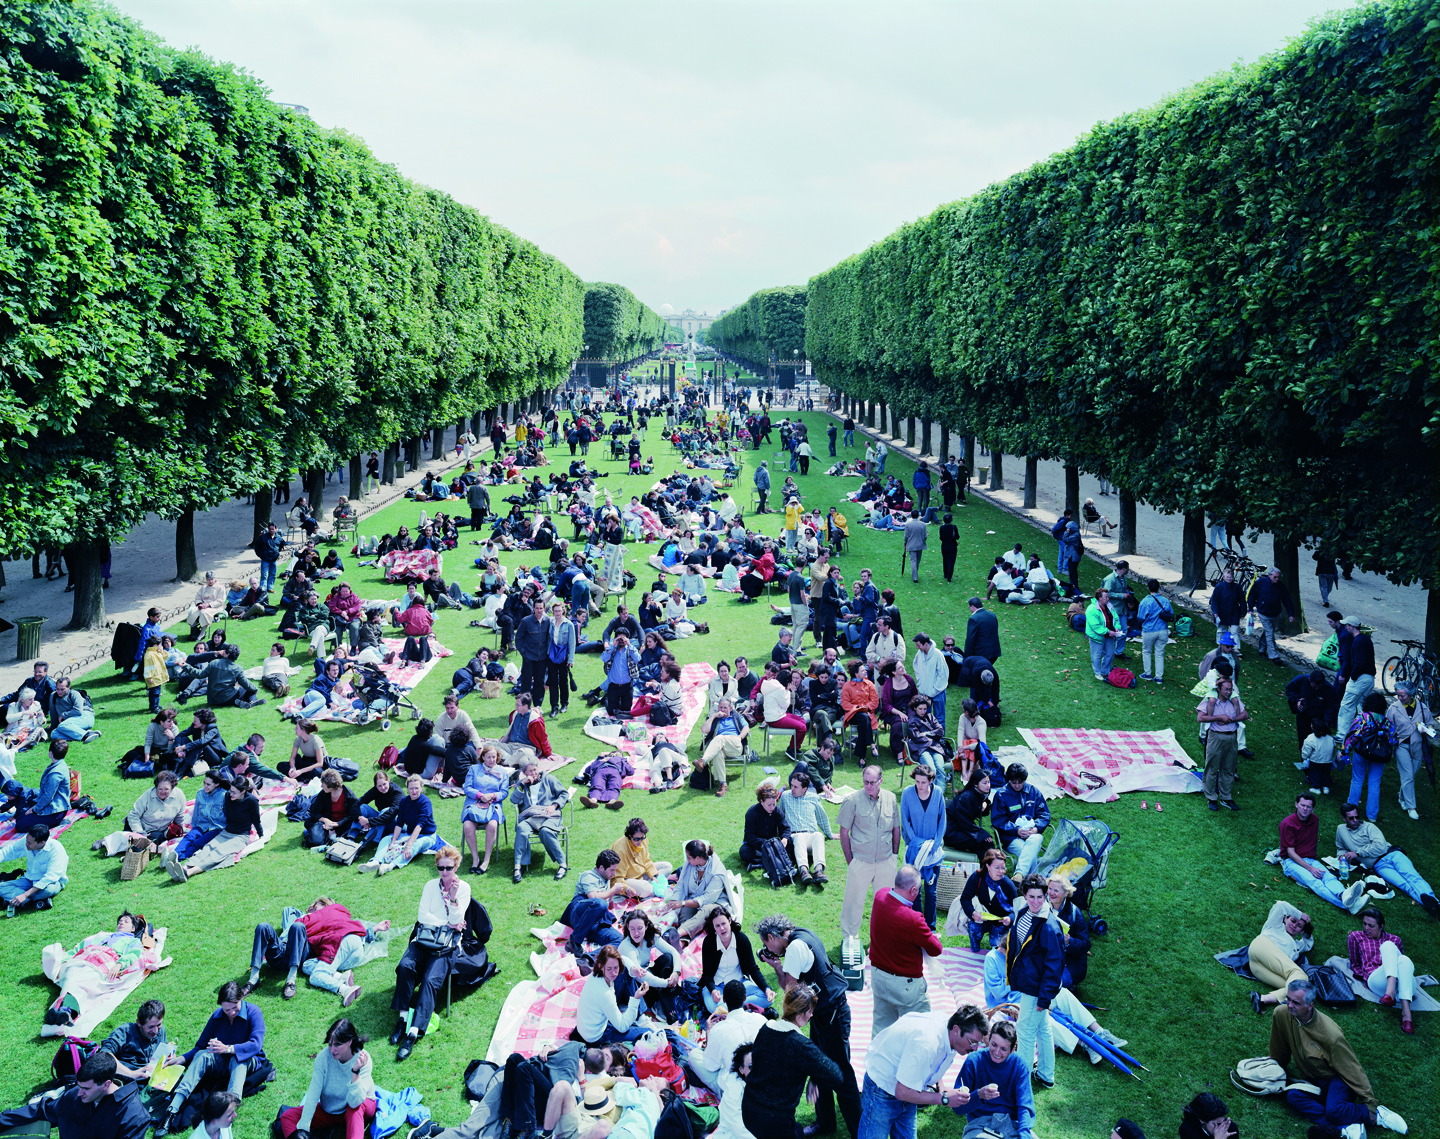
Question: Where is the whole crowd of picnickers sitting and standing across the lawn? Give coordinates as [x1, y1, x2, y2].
[0, 393, 1422, 1139]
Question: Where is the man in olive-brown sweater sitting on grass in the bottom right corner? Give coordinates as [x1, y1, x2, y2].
[1269, 979, 1407, 1136]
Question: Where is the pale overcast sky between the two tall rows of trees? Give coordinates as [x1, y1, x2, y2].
[115, 0, 1335, 311]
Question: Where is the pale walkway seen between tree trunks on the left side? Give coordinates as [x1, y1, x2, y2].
[0, 426, 466, 694]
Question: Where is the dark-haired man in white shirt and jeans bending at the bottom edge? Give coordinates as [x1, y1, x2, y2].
[855, 1005, 985, 1139]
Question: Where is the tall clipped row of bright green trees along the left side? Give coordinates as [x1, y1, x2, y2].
[0, 0, 658, 626]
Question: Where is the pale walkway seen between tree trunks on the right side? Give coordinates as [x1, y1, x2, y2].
[816, 399, 1426, 664]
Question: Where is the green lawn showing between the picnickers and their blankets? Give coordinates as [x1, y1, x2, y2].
[0, 413, 1440, 1139]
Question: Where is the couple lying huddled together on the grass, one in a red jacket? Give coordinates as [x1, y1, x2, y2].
[240, 896, 390, 1008]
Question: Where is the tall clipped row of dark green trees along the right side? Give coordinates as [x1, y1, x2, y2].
[805, 0, 1440, 645]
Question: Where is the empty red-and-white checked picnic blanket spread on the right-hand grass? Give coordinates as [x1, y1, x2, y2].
[1020, 727, 1201, 803]
